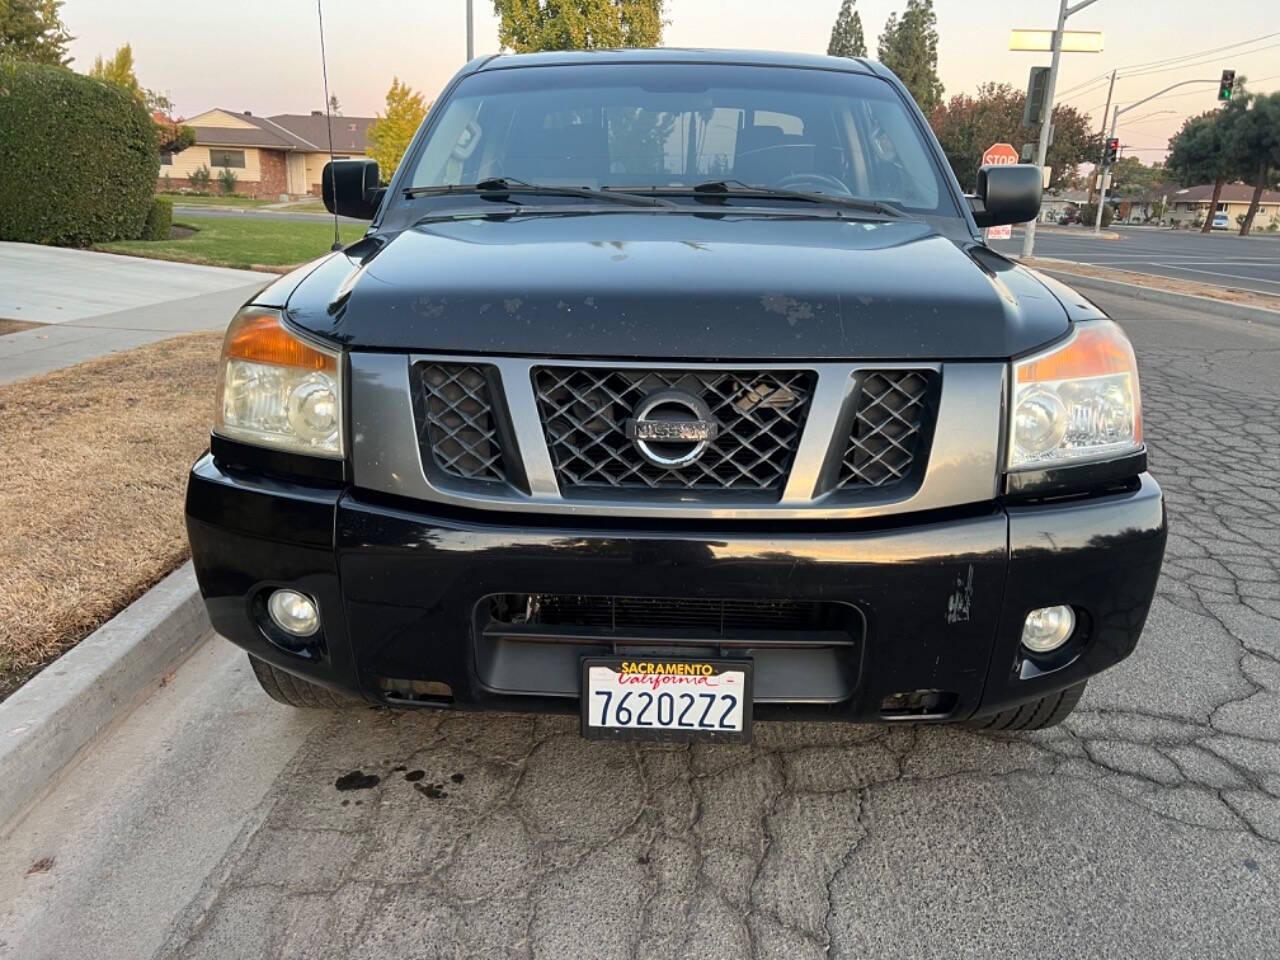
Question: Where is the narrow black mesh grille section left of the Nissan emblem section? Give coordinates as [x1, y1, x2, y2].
[411, 362, 509, 483]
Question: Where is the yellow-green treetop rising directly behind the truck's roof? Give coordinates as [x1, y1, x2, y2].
[493, 0, 666, 54]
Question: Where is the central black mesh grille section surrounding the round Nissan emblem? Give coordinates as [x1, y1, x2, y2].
[532, 366, 814, 492]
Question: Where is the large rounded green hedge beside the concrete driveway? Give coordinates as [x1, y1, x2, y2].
[0, 58, 160, 246]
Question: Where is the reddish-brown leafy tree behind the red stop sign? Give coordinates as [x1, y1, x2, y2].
[929, 83, 1102, 189]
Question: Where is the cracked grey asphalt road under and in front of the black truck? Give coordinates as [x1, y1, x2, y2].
[0, 294, 1280, 960]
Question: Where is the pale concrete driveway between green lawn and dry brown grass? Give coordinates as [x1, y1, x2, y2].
[0, 243, 266, 383]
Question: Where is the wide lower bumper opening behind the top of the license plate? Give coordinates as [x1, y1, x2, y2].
[475, 594, 864, 703]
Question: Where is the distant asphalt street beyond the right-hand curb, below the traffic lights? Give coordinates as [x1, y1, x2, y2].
[992, 227, 1280, 294]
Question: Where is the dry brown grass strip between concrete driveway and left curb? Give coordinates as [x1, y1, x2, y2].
[0, 333, 221, 699]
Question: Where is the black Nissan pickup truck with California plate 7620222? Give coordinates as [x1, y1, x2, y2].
[187, 50, 1166, 741]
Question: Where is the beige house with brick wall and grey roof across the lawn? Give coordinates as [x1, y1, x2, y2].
[159, 108, 374, 197]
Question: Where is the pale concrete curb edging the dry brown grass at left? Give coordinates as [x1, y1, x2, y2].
[0, 561, 210, 832]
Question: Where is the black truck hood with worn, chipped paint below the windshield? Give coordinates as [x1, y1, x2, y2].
[277, 210, 1068, 360]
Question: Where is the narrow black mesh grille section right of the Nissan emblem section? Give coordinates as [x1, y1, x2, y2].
[836, 370, 933, 489]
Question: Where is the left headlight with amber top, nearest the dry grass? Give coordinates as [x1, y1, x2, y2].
[214, 307, 343, 457]
